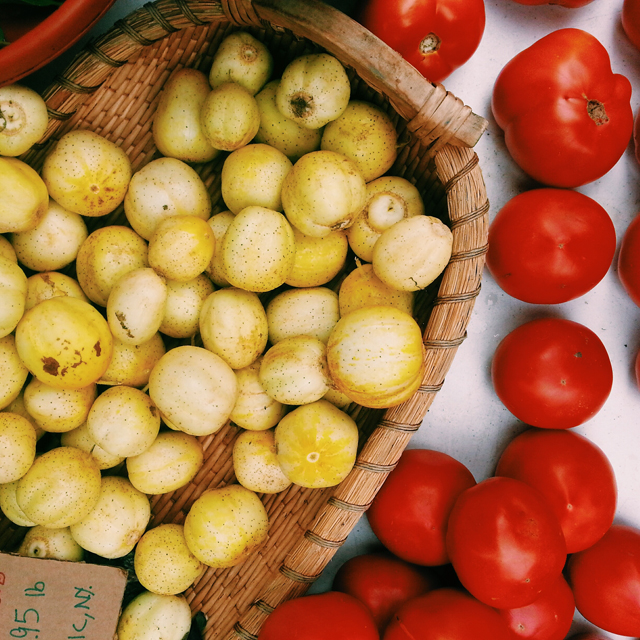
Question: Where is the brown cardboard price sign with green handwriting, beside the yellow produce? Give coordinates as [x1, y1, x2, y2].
[0, 553, 127, 640]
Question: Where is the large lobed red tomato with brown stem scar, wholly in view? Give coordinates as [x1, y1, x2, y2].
[491, 29, 633, 187]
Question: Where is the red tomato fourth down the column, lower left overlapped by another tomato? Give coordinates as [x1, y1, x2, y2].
[496, 429, 618, 553]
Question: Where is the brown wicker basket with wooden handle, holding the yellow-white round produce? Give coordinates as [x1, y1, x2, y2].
[0, 0, 489, 640]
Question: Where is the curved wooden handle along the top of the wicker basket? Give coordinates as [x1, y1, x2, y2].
[228, 0, 487, 151]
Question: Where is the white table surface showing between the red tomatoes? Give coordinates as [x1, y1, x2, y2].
[27, 0, 640, 638]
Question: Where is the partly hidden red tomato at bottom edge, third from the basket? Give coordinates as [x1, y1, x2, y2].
[499, 575, 576, 640]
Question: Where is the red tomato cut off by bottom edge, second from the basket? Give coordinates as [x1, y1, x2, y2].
[384, 589, 512, 640]
